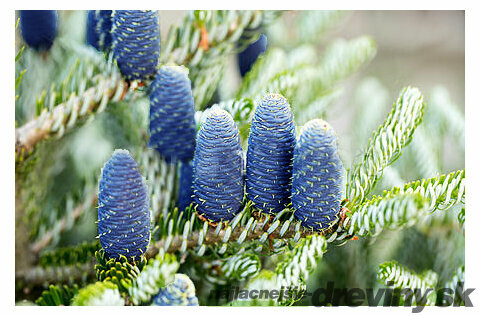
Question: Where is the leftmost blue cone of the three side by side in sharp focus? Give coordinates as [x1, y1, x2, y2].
[193, 109, 244, 223]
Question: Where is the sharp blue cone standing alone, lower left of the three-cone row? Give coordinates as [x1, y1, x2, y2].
[98, 149, 150, 259]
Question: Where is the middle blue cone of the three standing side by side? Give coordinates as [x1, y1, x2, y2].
[245, 94, 296, 214]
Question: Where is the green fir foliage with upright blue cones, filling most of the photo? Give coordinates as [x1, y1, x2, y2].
[15, 10, 466, 306]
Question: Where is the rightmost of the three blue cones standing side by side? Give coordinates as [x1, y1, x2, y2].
[292, 119, 343, 231]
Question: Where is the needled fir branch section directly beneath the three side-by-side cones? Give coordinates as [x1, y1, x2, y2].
[147, 203, 337, 257]
